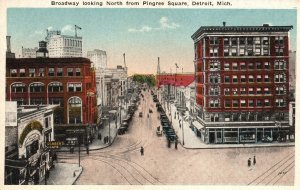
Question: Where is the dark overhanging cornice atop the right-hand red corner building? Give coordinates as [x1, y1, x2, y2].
[191, 25, 293, 40]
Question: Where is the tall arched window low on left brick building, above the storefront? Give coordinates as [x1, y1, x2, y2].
[68, 97, 82, 124]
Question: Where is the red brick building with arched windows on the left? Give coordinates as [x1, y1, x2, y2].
[6, 57, 96, 142]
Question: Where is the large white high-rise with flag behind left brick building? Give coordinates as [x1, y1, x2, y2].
[46, 31, 82, 58]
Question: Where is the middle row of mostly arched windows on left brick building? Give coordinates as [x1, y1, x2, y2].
[11, 82, 85, 93]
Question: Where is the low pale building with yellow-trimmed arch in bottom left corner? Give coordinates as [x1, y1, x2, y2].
[5, 102, 56, 185]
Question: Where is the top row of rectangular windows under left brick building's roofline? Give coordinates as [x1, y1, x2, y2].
[10, 68, 81, 77]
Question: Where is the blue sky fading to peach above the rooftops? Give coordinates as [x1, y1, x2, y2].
[7, 8, 297, 73]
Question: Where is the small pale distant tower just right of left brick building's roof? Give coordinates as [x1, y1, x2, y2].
[87, 49, 107, 70]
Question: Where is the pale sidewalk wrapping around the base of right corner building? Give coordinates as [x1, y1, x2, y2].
[165, 103, 295, 149]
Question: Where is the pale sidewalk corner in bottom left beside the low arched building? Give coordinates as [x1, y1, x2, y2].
[40, 162, 83, 185]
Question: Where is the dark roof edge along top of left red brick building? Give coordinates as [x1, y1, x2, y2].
[6, 57, 92, 64]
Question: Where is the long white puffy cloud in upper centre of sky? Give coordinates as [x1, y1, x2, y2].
[128, 17, 180, 33]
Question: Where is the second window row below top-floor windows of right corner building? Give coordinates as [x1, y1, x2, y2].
[209, 73, 286, 84]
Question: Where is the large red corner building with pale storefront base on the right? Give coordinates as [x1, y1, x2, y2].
[192, 23, 292, 143]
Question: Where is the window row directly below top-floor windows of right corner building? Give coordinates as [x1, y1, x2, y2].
[209, 60, 287, 71]
